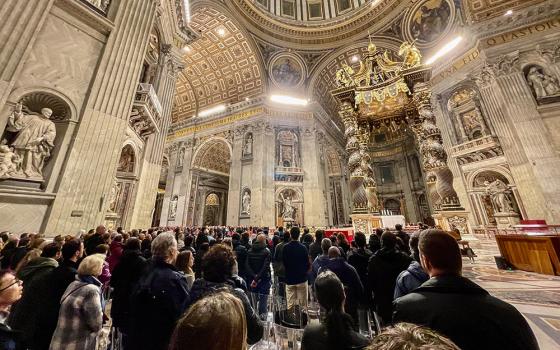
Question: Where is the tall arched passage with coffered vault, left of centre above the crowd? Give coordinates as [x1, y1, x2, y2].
[186, 137, 232, 226]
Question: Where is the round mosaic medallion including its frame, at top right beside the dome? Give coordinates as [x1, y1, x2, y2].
[405, 0, 455, 47]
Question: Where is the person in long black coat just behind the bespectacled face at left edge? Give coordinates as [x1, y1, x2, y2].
[8, 243, 60, 344]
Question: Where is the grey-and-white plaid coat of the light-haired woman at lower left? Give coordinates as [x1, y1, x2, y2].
[50, 280, 103, 350]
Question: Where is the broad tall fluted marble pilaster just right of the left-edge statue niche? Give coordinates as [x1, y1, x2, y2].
[43, 0, 157, 233]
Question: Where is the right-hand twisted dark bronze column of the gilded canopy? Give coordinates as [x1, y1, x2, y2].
[412, 84, 462, 210]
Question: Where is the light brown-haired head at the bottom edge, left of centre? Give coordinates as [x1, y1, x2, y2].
[169, 291, 247, 350]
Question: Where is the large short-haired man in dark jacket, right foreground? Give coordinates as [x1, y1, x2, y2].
[393, 230, 539, 350]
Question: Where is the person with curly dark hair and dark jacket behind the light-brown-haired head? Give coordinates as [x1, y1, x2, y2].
[189, 244, 264, 345]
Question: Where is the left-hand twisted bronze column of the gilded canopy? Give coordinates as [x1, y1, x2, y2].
[339, 103, 368, 214]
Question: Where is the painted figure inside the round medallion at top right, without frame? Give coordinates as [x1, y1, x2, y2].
[411, 0, 451, 42]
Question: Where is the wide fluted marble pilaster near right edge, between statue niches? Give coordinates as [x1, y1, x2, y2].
[473, 57, 560, 222]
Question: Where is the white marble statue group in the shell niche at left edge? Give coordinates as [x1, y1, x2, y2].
[0, 103, 56, 180]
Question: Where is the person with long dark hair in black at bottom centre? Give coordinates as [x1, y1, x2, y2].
[301, 270, 369, 350]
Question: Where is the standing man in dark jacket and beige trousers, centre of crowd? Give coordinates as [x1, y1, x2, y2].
[282, 227, 311, 309]
